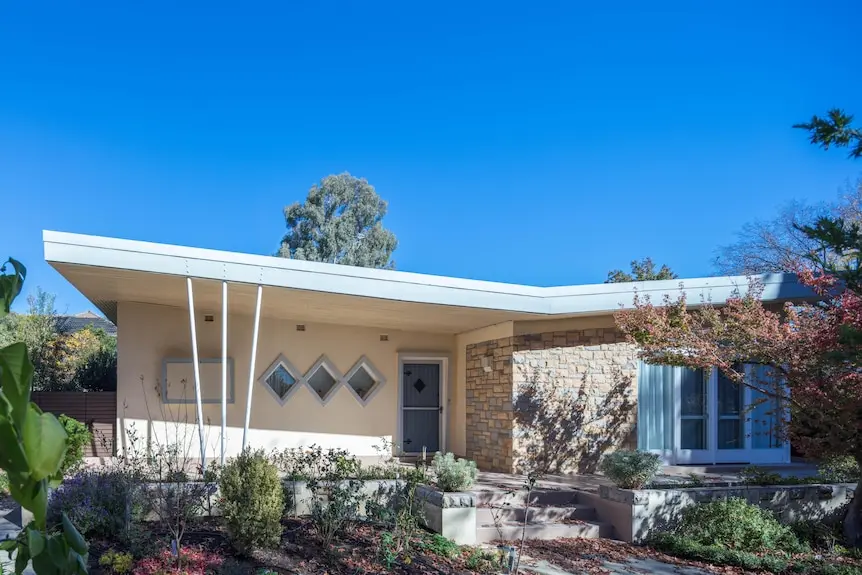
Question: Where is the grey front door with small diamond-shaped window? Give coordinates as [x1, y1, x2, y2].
[401, 363, 443, 453]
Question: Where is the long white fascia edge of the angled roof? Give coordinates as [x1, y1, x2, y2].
[43, 230, 813, 326]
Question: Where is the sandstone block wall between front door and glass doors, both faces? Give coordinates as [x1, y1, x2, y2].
[466, 328, 637, 473]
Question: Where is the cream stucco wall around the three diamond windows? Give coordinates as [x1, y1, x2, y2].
[117, 302, 466, 457]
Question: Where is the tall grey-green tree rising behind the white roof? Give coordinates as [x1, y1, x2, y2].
[278, 172, 398, 269]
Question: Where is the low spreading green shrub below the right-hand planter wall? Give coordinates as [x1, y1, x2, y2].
[676, 497, 803, 552]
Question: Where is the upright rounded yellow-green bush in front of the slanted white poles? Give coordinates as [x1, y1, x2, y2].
[219, 450, 284, 553]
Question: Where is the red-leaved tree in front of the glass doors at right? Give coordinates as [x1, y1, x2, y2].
[616, 270, 862, 545]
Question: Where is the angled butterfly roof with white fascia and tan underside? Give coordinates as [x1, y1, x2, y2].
[43, 231, 812, 333]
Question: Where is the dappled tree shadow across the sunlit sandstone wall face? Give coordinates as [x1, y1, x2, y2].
[513, 369, 635, 475]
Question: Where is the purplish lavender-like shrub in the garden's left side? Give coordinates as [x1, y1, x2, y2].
[48, 470, 144, 541]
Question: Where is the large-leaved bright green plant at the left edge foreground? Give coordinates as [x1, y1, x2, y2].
[0, 258, 88, 575]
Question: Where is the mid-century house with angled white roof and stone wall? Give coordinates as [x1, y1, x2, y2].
[44, 231, 809, 472]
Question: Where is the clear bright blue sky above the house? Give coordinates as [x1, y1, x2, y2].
[0, 0, 862, 312]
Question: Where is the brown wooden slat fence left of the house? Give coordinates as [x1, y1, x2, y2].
[30, 391, 117, 457]
